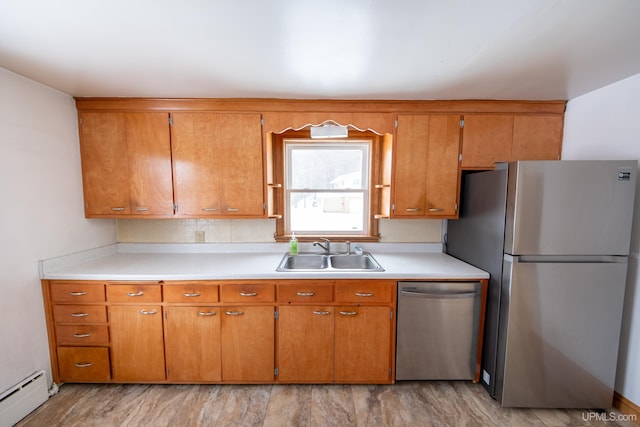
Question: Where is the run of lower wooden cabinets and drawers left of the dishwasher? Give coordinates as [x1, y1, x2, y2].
[43, 280, 396, 384]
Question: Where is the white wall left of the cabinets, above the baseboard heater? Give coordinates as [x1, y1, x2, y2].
[0, 68, 116, 393]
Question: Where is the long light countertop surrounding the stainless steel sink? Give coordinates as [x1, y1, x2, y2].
[40, 244, 489, 280]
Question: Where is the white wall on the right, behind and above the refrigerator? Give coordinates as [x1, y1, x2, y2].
[562, 74, 640, 405]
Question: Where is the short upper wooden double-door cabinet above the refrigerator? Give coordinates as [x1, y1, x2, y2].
[461, 114, 564, 169]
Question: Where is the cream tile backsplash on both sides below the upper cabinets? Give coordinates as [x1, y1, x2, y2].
[117, 219, 443, 243]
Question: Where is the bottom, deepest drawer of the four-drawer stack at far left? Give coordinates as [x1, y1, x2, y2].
[58, 347, 111, 381]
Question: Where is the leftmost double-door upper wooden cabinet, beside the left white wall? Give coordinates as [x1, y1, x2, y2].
[79, 111, 173, 218]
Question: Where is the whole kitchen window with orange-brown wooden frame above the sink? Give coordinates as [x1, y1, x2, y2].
[270, 131, 382, 241]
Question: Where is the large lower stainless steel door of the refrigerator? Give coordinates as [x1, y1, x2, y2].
[496, 257, 627, 408]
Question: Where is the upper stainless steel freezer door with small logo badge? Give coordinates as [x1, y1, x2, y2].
[505, 160, 638, 255]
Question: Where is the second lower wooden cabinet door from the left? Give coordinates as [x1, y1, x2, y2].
[165, 307, 222, 382]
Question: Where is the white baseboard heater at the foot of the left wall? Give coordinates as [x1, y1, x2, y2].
[0, 371, 49, 427]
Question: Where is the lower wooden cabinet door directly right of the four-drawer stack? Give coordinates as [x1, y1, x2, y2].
[109, 305, 165, 381]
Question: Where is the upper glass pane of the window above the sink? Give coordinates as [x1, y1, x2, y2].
[288, 145, 368, 190]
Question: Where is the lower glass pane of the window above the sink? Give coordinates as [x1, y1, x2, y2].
[289, 192, 365, 234]
